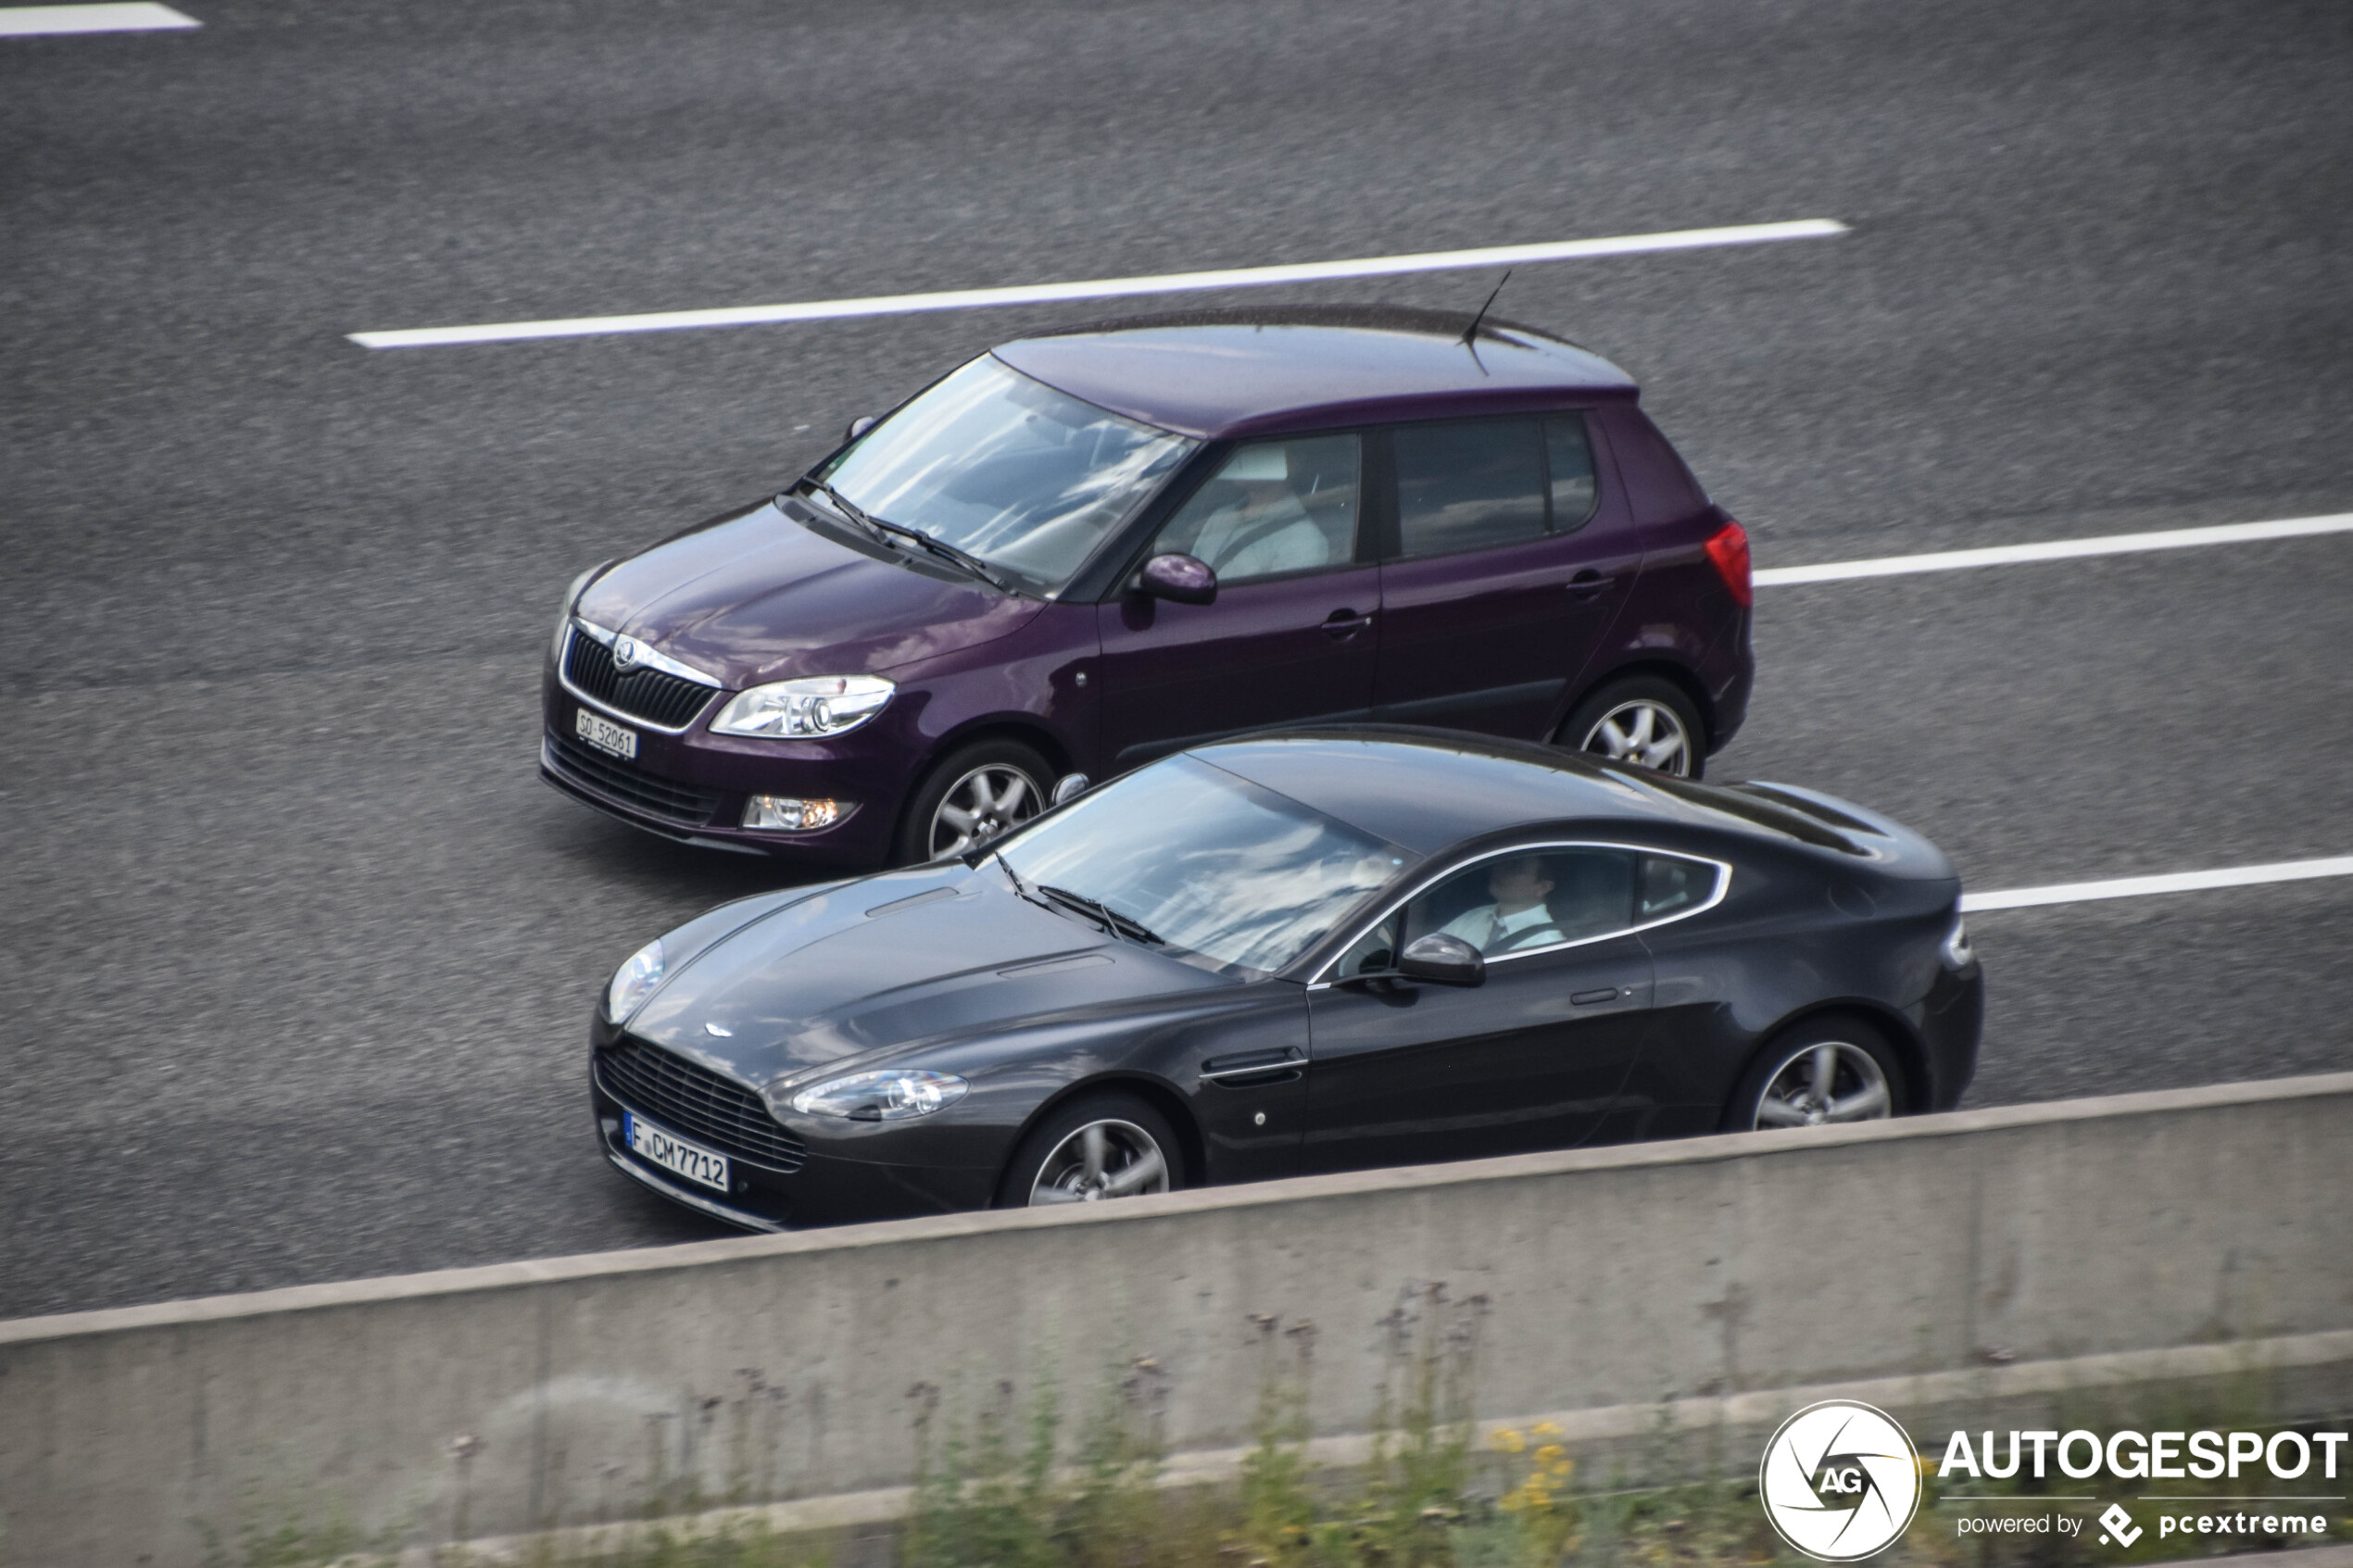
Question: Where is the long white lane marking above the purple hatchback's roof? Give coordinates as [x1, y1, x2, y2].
[348, 219, 1847, 348]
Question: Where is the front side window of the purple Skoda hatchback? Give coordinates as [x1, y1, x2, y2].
[1153, 435, 1358, 585]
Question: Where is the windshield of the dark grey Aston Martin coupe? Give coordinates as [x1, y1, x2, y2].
[1002, 757, 1419, 973]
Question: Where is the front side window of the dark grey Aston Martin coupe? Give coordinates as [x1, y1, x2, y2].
[1403, 848, 1635, 960]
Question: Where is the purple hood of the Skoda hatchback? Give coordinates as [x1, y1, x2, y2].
[579, 503, 1040, 686]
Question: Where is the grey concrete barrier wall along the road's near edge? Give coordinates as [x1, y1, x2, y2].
[13, 1074, 2353, 1568]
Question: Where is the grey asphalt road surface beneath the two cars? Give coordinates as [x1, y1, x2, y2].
[0, 0, 2353, 1316]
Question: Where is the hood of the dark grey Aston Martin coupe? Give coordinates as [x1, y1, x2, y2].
[628, 865, 1226, 1084]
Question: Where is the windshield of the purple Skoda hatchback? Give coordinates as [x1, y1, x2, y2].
[816, 355, 1195, 593]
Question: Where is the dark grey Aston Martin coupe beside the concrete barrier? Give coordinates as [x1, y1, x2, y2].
[591, 729, 1983, 1229]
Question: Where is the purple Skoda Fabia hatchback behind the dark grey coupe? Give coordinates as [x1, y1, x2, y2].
[541, 308, 1753, 865]
